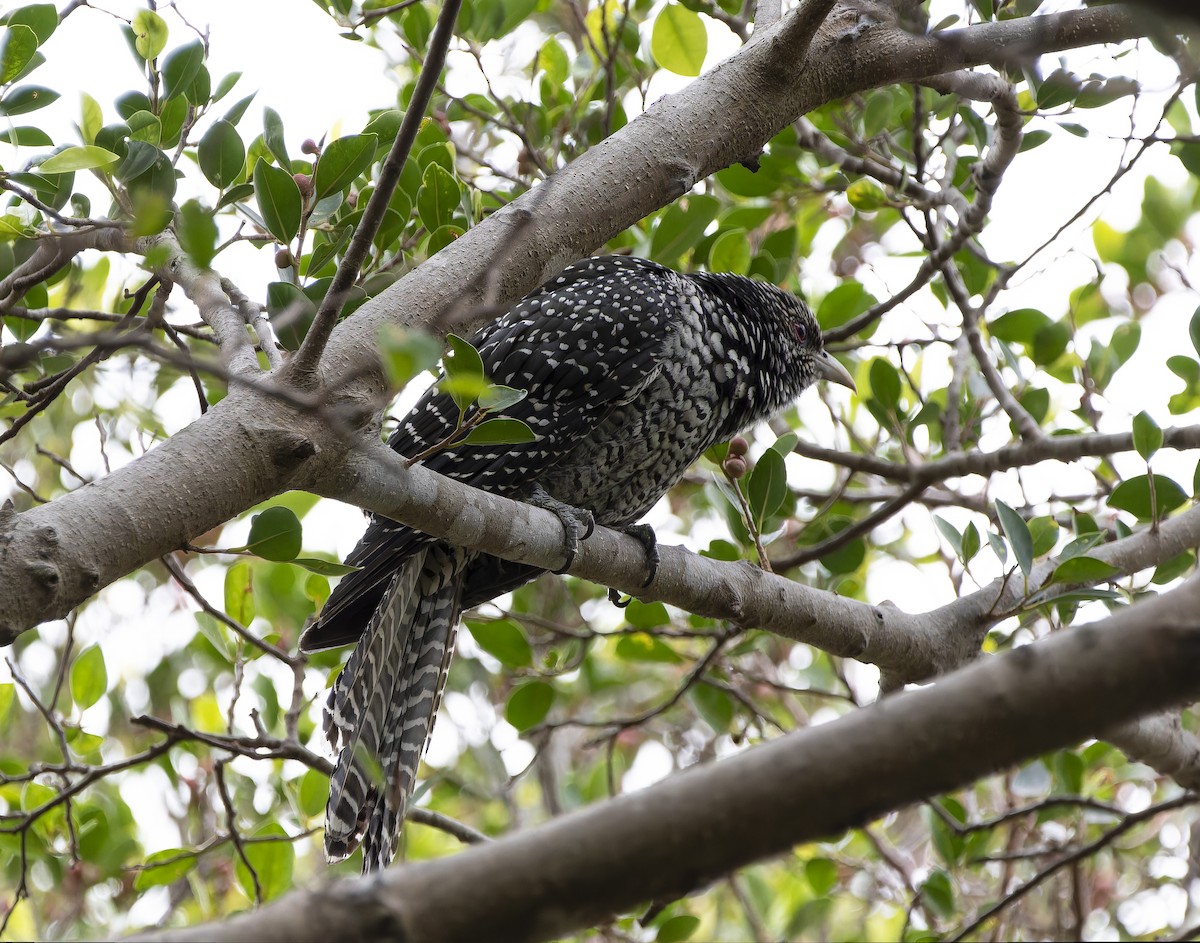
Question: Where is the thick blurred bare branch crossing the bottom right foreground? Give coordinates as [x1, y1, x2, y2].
[129, 578, 1200, 943]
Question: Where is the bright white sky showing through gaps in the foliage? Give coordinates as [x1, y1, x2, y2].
[0, 0, 1200, 921]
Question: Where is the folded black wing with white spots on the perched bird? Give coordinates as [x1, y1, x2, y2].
[301, 256, 680, 651]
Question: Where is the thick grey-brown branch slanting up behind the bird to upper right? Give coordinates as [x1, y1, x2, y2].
[0, 7, 1144, 643]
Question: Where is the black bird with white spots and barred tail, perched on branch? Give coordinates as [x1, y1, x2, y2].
[300, 256, 854, 873]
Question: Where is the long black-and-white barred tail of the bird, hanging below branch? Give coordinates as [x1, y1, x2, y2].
[325, 543, 470, 872]
